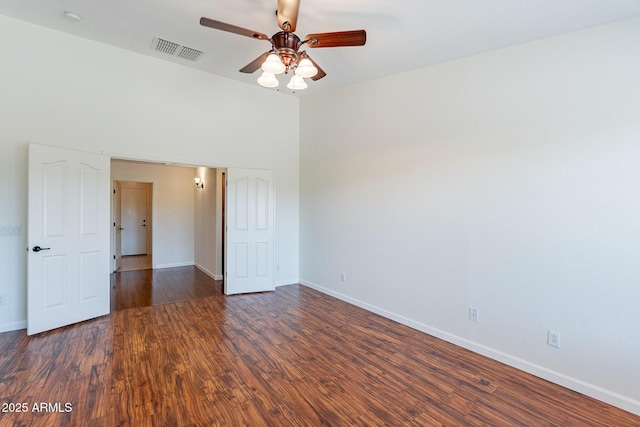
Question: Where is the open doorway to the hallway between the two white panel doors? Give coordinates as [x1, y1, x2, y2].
[111, 159, 224, 311]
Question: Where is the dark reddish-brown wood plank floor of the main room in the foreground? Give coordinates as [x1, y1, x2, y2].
[0, 285, 640, 426]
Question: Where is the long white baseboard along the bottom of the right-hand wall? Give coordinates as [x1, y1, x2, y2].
[300, 280, 640, 415]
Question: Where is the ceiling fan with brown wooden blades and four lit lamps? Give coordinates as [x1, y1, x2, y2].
[200, 0, 367, 91]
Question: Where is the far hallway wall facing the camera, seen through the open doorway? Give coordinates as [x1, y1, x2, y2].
[111, 160, 195, 268]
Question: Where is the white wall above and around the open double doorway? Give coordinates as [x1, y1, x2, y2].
[0, 16, 299, 331]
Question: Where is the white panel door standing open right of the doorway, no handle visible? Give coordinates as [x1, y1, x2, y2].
[224, 169, 275, 295]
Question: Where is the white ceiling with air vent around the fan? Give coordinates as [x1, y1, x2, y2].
[0, 0, 640, 95]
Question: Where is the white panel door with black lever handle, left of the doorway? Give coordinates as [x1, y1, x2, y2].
[27, 144, 110, 335]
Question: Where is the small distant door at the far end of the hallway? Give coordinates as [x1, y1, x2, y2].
[120, 187, 148, 255]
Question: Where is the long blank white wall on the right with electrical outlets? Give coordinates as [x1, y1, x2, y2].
[300, 19, 640, 413]
